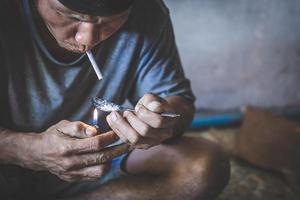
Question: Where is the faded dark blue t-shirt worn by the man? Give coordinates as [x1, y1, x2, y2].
[0, 0, 194, 132]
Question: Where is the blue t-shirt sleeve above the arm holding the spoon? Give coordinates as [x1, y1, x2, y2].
[129, 19, 195, 104]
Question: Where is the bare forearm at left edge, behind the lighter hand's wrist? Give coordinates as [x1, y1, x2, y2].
[0, 127, 34, 166]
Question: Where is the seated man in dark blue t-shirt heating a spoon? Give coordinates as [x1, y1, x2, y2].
[0, 0, 229, 200]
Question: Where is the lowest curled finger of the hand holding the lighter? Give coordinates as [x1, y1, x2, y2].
[67, 163, 111, 181]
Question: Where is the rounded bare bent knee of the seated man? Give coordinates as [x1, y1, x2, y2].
[172, 138, 230, 199]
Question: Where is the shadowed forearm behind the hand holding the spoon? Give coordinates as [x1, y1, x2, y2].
[166, 96, 195, 139]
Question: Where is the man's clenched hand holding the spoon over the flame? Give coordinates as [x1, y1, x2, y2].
[106, 94, 178, 149]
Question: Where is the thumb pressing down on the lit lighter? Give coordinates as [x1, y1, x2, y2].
[56, 122, 97, 138]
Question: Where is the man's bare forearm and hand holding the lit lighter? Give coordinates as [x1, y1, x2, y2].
[0, 121, 129, 182]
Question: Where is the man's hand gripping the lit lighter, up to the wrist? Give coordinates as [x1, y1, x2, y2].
[23, 120, 129, 182]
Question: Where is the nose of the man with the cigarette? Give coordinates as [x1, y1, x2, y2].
[75, 22, 100, 47]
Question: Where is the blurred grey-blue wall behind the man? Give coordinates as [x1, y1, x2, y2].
[165, 0, 300, 110]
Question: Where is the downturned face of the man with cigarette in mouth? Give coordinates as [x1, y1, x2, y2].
[36, 0, 130, 53]
